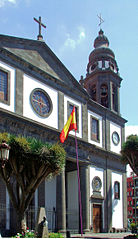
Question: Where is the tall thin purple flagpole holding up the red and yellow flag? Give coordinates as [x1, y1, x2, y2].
[75, 130, 83, 236]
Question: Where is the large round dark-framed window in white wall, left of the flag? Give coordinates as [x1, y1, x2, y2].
[30, 88, 52, 117]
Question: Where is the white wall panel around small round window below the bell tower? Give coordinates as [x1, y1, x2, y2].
[110, 122, 121, 154]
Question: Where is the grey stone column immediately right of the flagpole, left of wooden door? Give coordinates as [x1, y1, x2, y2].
[80, 165, 90, 232]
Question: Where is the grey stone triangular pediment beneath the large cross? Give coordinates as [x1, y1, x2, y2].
[0, 35, 89, 98]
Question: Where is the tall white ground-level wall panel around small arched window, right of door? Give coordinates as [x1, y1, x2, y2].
[112, 172, 123, 228]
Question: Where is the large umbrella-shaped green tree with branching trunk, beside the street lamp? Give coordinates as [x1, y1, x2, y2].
[0, 133, 66, 232]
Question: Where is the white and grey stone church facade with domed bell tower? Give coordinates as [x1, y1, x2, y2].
[0, 27, 127, 232]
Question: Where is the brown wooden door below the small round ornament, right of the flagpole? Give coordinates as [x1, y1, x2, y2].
[93, 204, 102, 232]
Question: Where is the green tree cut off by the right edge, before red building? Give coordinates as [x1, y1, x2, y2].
[121, 135, 138, 176]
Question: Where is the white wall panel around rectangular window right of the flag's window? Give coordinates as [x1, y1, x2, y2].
[88, 111, 102, 147]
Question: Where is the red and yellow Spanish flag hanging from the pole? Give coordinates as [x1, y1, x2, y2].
[60, 106, 77, 143]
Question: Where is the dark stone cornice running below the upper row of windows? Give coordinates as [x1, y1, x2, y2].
[0, 108, 125, 166]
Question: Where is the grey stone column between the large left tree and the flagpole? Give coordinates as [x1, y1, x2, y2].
[56, 171, 66, 232]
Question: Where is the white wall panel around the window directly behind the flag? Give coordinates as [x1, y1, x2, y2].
[64, 95, 82, 138]
